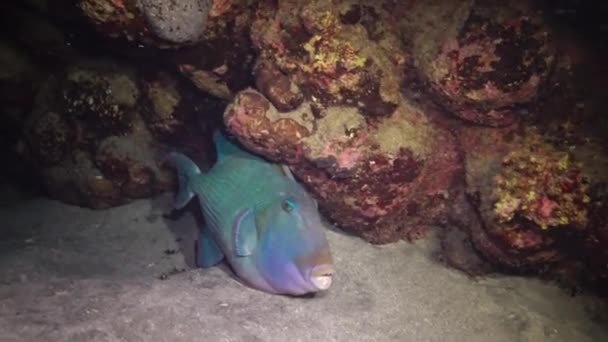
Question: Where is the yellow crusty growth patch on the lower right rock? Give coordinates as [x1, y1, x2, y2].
[492, 131, 589, 229]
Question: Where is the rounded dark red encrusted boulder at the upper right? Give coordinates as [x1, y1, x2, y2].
[402, 1, 555, 126]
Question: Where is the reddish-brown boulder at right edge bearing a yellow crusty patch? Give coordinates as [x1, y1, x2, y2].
[451, 126, 608, 292]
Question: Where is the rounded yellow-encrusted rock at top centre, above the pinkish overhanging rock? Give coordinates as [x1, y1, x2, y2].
[251, 1, 407, 116]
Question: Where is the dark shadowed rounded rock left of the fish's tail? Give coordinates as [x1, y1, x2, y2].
[20, 63, 216, 208]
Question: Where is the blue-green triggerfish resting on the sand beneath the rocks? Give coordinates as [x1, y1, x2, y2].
[168, 130, 334, 295]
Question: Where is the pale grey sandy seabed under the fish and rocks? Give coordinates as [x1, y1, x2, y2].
[0, 191, 608, 342]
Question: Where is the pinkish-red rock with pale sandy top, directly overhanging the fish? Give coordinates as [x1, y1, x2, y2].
[224, 90, 459, 243]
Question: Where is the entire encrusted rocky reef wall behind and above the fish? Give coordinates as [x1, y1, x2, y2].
[0, 0, 608, 296]
